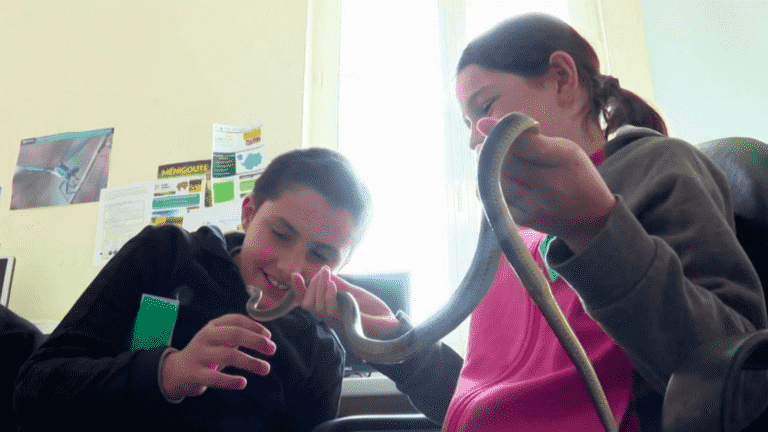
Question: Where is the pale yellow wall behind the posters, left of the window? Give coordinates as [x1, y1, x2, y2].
[0, 0, 307, 323]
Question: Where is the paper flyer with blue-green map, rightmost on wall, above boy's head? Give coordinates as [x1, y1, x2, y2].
[211, 123, 267, 206]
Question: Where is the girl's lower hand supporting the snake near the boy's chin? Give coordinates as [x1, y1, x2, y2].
[291, 266, 398, 339]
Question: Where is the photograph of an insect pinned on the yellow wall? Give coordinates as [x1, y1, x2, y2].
[11, 128, 115, 210]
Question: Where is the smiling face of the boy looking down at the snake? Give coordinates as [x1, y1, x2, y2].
[237, 188, 356, 309]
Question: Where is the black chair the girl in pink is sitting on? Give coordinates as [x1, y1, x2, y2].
[315, 138, 768, 432]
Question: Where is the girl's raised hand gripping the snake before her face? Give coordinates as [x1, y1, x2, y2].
[477, 118, 616, 253]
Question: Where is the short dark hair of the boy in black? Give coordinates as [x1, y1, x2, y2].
[252, 148, 370, 249]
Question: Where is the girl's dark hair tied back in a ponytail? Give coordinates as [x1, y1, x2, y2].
[456, 13, 667, 138]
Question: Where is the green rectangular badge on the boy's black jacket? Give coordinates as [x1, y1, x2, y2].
[131, 294, 179, 351]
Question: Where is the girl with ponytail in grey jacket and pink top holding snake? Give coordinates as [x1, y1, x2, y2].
[302, 14, 766, 431]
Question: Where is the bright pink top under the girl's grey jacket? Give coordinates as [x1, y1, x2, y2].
[443, 148, 640, 432]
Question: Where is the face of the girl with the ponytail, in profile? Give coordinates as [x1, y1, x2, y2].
[457, 64, 564, 152]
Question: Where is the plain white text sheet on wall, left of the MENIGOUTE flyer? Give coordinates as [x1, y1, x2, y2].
[93, 182, 155, 265]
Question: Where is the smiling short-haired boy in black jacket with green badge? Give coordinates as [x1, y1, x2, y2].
[14, 149, 376, 432]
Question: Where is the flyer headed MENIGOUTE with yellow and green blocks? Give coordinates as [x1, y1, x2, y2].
[150, 160, 211, 226]
